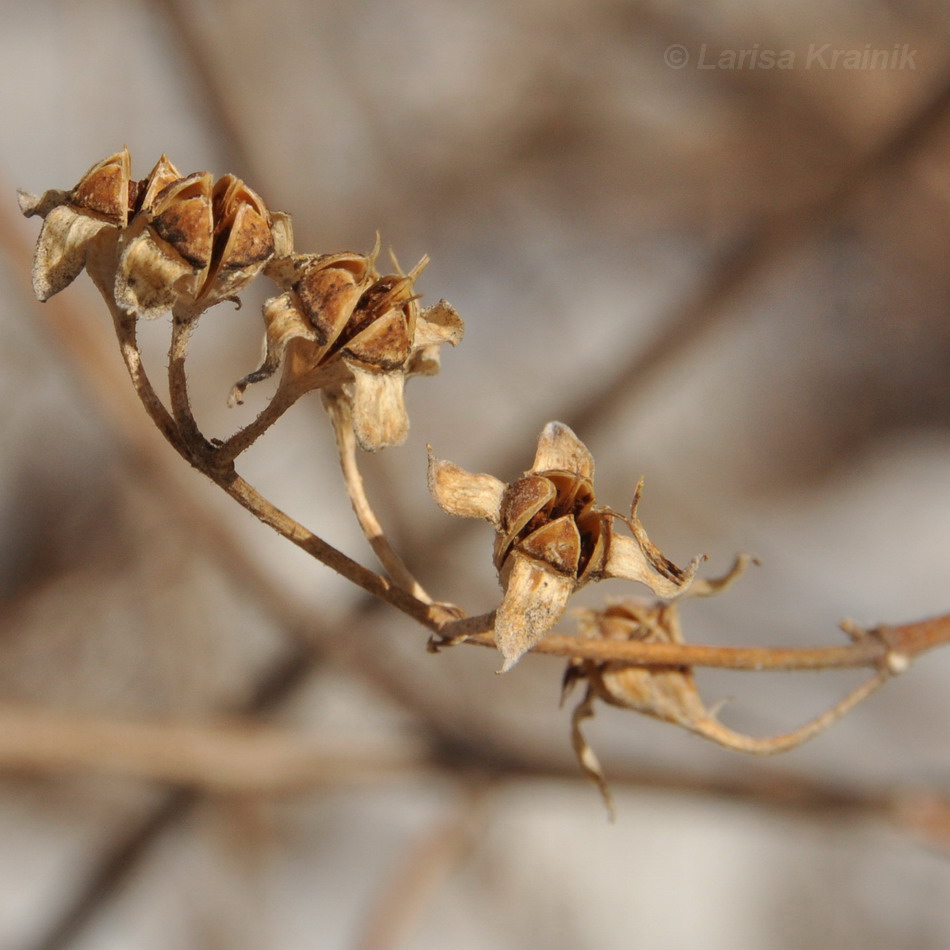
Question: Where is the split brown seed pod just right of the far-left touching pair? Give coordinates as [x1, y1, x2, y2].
[231, 250, 463, 451]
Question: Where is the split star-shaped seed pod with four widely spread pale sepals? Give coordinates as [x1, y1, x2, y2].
[429, 422, 699, 672]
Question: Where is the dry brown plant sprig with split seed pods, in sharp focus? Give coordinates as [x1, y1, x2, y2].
[19, 149, 950, 820]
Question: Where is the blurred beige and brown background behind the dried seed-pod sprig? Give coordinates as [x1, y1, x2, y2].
[0, 0, 950, 950]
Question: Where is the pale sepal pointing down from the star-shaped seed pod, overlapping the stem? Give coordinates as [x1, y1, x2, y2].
[495, 552, 577, 673]
